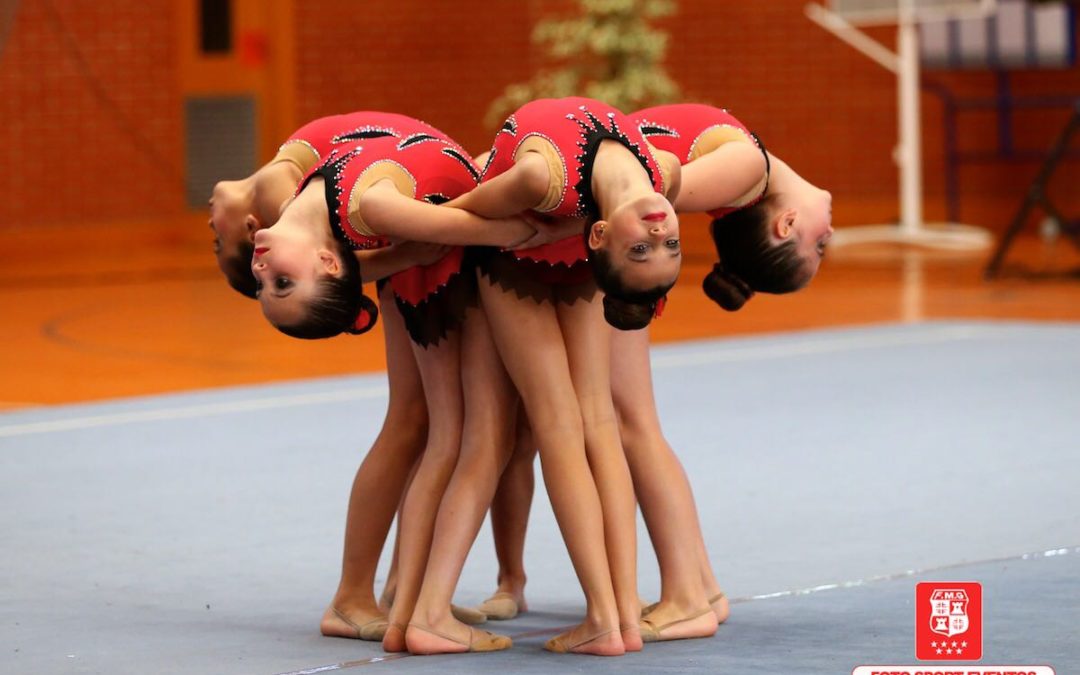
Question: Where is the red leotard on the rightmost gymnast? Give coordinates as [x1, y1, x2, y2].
[627, 104, 769, 218]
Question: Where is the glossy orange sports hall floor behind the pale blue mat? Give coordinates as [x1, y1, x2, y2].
[0, 214, 1080, 409]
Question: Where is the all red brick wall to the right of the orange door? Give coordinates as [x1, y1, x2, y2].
[297, 0, 1080, 228]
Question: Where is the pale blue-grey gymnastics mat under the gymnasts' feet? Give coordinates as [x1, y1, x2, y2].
[0, 322, 1080, 675]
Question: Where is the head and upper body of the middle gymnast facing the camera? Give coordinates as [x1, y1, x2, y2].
[470, 98, 681, 327]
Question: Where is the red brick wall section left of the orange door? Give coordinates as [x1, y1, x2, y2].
[0, 0, 184, 226]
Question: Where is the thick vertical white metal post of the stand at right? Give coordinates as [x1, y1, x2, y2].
[896, 0, 922, 234]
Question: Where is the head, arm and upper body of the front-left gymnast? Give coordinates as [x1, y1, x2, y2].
[252, 125, 557, 336]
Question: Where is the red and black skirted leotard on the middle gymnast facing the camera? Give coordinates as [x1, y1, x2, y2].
[480, 97, 667, 299]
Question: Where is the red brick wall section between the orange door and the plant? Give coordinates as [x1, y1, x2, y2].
[296, 0, 542, 152]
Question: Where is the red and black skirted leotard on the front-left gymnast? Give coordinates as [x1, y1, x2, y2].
[298, 130, 480, 346]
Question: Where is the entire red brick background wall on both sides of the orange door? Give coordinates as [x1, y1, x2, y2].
[0, 0, 1080, 227]
